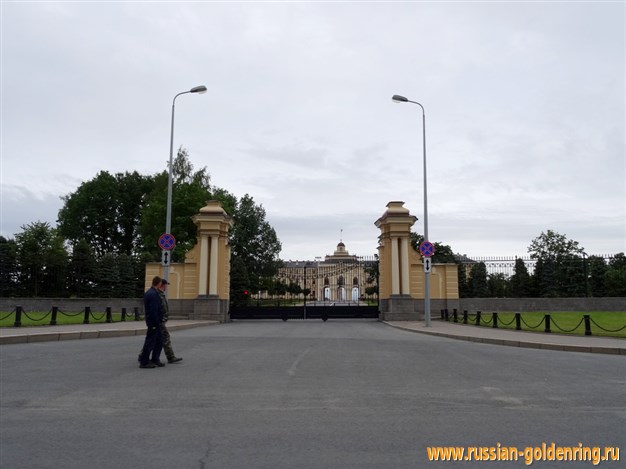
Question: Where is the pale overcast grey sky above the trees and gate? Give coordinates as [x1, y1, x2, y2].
[0, 1, 626, 260]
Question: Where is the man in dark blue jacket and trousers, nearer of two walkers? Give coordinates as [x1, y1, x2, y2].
[139, 276, 165, 368]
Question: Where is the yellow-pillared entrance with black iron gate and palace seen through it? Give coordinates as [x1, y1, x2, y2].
[145, 197, 459, 322]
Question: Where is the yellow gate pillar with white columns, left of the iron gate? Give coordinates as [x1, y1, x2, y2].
[190, 200, 233, 322]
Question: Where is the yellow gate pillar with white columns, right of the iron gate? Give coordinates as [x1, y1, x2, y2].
[376, 201, 423, 321]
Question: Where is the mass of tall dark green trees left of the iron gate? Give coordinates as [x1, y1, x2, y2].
[0, 148, 281, 298]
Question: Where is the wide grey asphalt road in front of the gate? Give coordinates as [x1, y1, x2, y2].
[0, 320, 626, 469]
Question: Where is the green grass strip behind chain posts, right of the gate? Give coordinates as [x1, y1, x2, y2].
[459, 311, 626, 338]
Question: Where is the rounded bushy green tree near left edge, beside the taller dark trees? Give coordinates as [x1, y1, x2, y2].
[15, 221, 68, 297]
